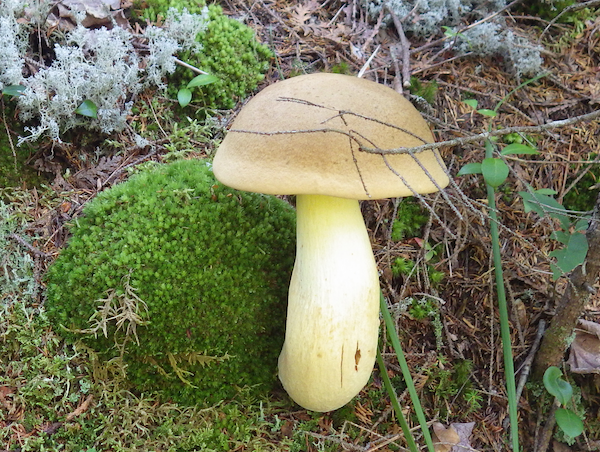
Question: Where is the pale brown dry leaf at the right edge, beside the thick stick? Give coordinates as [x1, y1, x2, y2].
[567, 319, 600, 374]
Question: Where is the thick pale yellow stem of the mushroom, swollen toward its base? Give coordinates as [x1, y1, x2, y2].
[279, 195, 379, 412]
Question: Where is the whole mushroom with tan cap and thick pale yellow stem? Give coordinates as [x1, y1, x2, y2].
[213, 73, 448, 412]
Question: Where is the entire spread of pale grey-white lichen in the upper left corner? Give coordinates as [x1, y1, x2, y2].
[0, 0, 208, 144]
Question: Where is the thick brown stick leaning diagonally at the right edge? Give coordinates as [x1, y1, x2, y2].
[533, 195, 600, 380]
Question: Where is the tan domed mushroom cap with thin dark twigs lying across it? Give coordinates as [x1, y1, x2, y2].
[213, 73, 448, 199]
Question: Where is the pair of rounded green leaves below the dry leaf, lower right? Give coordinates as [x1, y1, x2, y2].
[543, 366, 583, 444]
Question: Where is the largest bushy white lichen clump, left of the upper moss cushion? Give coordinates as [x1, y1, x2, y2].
[18, 26, 140, 142]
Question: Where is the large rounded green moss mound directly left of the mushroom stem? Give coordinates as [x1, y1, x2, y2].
[45, 161, 295, 405]
